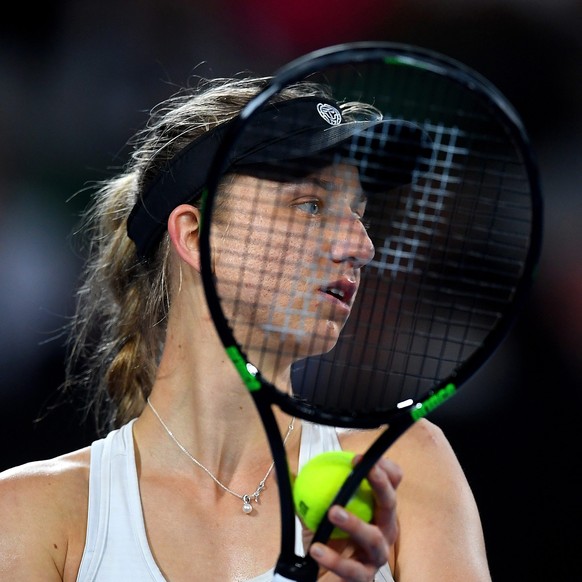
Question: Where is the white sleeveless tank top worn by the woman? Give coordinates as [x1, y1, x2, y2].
[77, 419, 394, 582]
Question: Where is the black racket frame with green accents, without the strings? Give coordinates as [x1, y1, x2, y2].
[200, 42, 543, 581]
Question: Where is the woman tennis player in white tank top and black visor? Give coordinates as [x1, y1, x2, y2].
[0, 78, 490, 582]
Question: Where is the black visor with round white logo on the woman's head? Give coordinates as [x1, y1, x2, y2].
[127, 97, 431, 258]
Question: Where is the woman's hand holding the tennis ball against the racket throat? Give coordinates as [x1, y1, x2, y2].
[304, 455, 402, 582]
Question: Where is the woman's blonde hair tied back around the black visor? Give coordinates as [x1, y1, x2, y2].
[65, 77, 380, 432]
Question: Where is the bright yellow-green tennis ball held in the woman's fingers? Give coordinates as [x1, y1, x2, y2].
[293, 451, 374, 539]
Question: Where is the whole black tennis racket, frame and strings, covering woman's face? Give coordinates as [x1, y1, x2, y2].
[200, 43, 542, 581]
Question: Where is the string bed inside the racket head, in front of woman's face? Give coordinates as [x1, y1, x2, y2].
[211, 58, 532, 418]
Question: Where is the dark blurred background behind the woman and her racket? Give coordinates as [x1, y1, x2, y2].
[0, 0, 582, 582]
